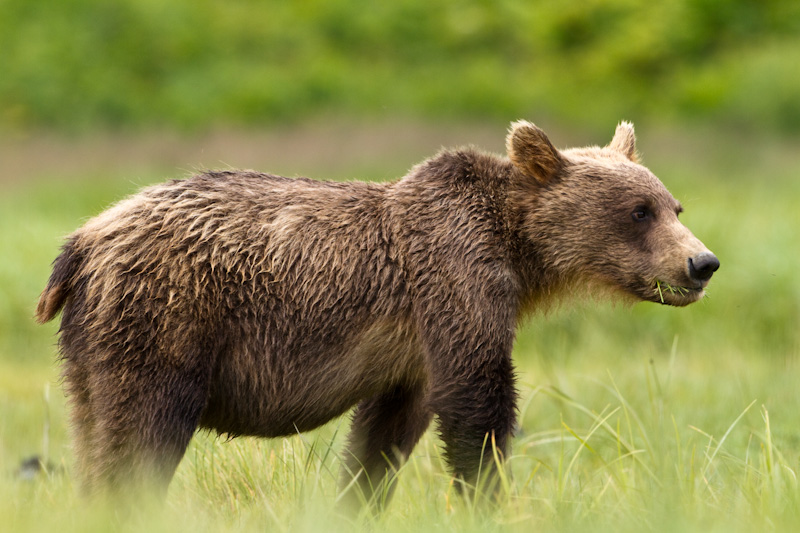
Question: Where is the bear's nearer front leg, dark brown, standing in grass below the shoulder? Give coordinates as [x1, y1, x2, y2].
[420, 286, 517, 494]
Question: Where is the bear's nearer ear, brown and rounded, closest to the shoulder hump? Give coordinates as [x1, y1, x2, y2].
[506, 120, 564, 183]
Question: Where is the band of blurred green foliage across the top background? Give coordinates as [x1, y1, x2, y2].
[0, 0, 800, 134]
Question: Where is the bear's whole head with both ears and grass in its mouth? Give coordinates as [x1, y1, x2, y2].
[507, 121, 719, 306]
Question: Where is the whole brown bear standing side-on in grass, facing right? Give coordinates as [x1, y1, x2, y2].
[36, 121, 719, 499]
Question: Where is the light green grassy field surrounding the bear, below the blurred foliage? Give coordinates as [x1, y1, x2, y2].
[0, 122, 800, 532]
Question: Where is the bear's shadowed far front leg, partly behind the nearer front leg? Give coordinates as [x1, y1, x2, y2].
[342, 384, 432, 508]
